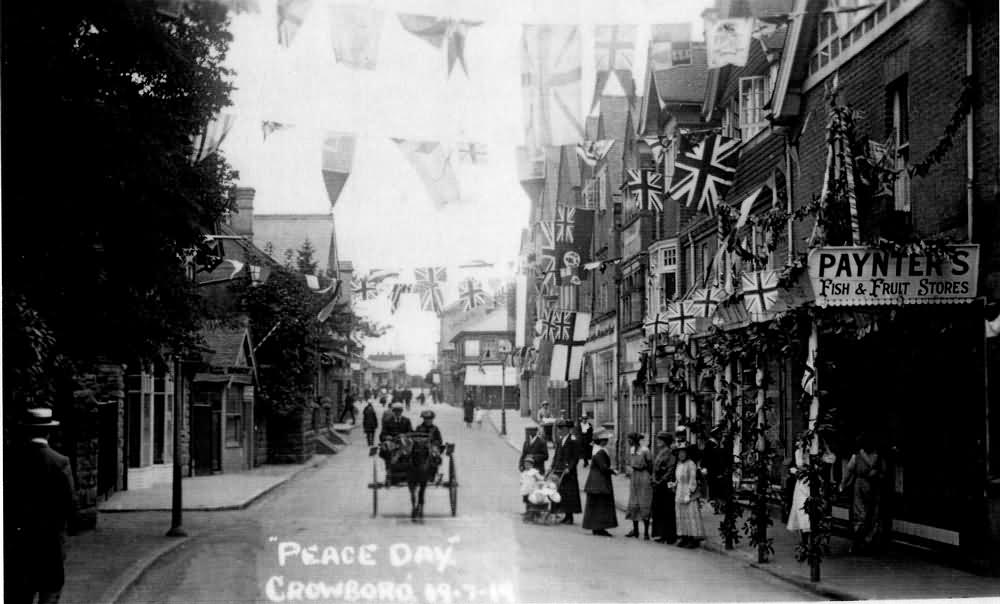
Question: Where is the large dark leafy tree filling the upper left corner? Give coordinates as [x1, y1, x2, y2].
[3, 0, 232, 402]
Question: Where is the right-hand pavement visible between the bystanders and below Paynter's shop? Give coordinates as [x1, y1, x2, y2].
[487, 410, 1000, 600]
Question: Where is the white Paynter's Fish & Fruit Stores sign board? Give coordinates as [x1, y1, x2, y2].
[809, 244, 979, 306]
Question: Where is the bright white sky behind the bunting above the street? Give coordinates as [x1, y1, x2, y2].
[222, 0, 710, 373]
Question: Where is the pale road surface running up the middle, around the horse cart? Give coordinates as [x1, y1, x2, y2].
[121, 404, 816, 604]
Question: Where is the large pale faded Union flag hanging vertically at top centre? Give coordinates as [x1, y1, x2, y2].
[521, 25, 584, 148]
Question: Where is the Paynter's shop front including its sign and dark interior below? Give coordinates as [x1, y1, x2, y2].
[809, 245, 990, 557]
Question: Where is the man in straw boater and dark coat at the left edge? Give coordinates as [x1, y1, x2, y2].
[5, 408, 75, 604]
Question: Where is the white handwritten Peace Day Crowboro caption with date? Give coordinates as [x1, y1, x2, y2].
[264, 535, 515, 604]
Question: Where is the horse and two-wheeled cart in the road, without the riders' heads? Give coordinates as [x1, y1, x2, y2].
[368, 432, 458, 519]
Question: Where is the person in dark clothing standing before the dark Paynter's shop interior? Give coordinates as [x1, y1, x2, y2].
[840, 436, 885, 554]
